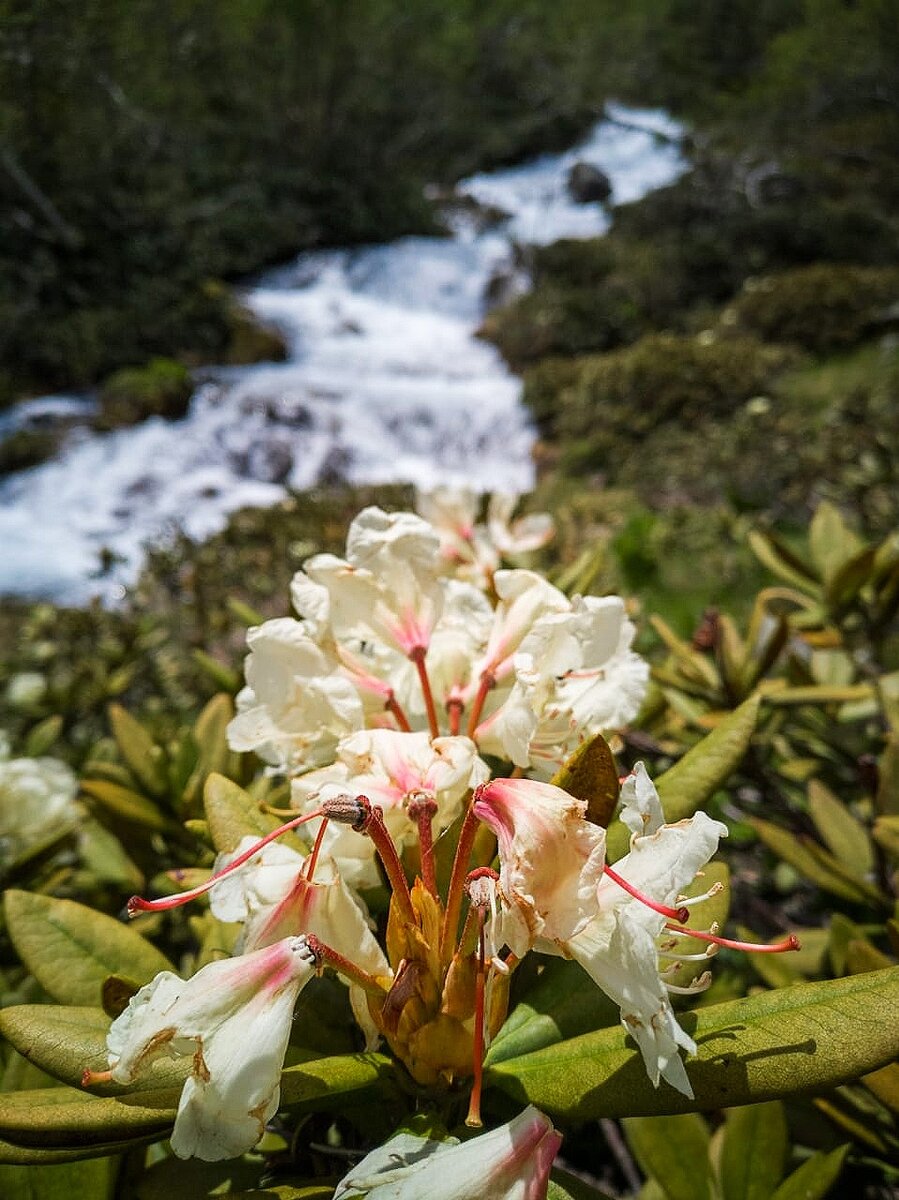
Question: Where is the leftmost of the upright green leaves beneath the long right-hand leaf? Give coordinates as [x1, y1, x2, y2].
[622, 1112, 709, 1200]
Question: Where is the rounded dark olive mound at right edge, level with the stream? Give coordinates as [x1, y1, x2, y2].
[723, 263, 899, 354]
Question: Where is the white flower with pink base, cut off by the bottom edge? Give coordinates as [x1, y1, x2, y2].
[334, 1105, 562, 1200]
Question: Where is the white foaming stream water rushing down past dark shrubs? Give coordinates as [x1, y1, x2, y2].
[0, 106, 683, 602]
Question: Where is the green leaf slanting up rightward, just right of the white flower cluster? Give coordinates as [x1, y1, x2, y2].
[606, 695, 761, 862]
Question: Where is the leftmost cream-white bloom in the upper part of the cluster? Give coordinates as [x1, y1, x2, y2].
[228, 617, 364, 768]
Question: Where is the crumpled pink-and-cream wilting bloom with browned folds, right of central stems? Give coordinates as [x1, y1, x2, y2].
[474, 779, 605, 958]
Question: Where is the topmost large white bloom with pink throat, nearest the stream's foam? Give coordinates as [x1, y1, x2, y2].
[293, 508, 443, 658]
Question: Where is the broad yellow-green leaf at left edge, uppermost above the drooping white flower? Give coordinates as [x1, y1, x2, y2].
[4, 890, 173, 1004]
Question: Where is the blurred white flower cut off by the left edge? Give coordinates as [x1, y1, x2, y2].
[0, 737, 79, 860]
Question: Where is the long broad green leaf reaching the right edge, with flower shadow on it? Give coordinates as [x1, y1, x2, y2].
[487, 967, 899, 1122]
